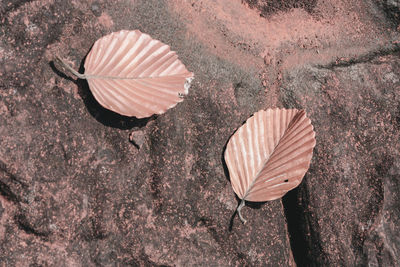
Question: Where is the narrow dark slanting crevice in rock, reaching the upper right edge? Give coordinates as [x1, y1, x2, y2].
[316, 44, 400, 70]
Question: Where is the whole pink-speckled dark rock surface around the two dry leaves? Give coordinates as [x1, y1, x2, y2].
[0, 0, 400, 266]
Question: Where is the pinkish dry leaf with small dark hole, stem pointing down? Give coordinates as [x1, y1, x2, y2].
[225, 109, 315, 222]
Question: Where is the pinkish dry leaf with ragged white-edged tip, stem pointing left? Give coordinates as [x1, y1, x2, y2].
[59, 30, 193, 118]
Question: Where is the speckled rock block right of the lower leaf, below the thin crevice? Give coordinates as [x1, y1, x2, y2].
[282, 52, 400, 266]
